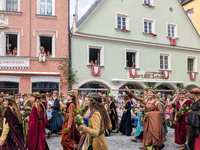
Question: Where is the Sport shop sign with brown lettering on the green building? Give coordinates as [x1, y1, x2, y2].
[136, 71, 166, 80]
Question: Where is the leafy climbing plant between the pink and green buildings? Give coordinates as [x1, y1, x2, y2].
[58, 57, 77, 87]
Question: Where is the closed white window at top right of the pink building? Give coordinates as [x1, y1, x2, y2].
[38, 0, 55, 15]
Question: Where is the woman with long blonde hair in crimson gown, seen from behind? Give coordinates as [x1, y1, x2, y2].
[26, 92, 49, 150]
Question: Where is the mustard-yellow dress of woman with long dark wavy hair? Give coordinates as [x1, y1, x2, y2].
[82, 111, 108, 150]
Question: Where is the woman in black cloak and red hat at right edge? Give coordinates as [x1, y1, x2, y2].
[187, 88, 200, 150]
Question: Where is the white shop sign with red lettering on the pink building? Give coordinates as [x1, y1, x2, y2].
[0, 57, 30, 67]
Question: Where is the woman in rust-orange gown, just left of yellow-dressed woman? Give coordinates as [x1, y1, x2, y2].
[61, 91, 77, 150]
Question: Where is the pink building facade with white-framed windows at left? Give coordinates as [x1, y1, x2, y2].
[0, 0, 69, 94]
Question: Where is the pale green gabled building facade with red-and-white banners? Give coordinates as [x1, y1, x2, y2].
[71, 0, 200, 95]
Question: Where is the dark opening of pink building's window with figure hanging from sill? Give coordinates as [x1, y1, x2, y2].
[40, 36, 52, 55]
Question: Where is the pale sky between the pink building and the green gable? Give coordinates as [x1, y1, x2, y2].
[70, 0, 95, 26]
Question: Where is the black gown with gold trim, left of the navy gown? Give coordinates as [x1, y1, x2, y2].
[109, 102, 118, 130]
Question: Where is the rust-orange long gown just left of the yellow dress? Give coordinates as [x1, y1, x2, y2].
[61, 103, 76, 150]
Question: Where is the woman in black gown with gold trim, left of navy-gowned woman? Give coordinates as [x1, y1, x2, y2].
[108, 93, 118, 130]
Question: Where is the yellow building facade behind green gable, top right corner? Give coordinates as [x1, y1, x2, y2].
[181, 0, 200, 34]
